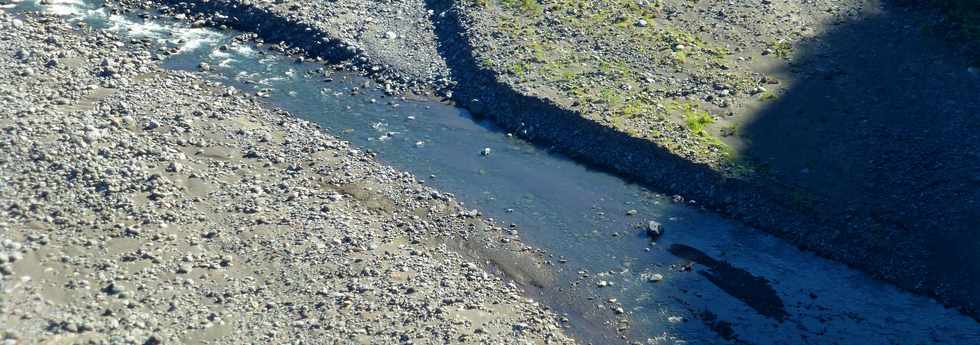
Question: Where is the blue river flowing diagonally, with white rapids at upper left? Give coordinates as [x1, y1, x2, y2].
[7, 1, 980, 344]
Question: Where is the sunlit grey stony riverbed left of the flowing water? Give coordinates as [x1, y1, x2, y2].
[0, 8, 572, 344]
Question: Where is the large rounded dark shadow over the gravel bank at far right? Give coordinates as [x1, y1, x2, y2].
[740, 0, 980, 317]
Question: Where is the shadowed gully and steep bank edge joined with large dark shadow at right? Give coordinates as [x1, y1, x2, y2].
[426, 0, 980, 326]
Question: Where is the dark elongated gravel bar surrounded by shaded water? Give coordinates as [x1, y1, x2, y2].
[669, 244, 789, 322]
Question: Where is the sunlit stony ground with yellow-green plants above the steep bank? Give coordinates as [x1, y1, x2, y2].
[468, 0, 755, 172]
